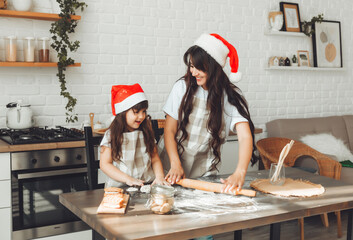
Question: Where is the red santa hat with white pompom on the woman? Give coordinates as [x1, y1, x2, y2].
[194, 33, 241, 82]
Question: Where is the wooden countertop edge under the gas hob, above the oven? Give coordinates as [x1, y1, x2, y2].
[0, 140, 85, 153]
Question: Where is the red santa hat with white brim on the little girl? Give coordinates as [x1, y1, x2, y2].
[111, 83, 147, 116]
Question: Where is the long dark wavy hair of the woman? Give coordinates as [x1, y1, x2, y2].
[177, 46, 259, 171]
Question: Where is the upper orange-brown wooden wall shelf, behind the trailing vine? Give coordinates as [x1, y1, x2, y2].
[0, 9, 81, 21]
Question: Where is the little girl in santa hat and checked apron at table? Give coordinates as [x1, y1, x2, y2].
[100, 84, 169, 187]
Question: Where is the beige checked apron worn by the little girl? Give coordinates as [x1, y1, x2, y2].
[105, 131, 154, 187]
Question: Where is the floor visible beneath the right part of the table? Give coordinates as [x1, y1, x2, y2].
[214, 211, 348, 240]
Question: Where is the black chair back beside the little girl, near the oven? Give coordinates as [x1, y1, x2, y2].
[85, 127, 104, 190]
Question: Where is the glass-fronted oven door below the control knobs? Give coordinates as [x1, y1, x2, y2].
[12, 167, 89, 239]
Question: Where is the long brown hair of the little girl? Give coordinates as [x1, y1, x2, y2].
[109, 100, 156, 162]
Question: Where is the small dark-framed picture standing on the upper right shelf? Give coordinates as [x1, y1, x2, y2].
[279, 2, 302, 32]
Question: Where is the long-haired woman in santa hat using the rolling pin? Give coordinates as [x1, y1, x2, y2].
[159, 34, 258, 191]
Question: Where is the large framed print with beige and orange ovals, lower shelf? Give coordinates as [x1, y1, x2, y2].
[312, 20, 343, 68]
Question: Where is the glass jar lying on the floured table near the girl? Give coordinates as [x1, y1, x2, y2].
[147, 184, 174, 214]
